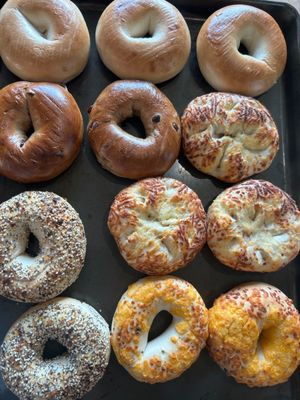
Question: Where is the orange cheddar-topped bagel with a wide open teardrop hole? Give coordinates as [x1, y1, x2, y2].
[111, 276, 208, 383]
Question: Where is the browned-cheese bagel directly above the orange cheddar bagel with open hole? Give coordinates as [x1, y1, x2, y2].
[108, 178, 206, 275]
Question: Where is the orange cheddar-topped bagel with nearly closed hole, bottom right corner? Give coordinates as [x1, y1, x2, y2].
[207, 283, 300, 386]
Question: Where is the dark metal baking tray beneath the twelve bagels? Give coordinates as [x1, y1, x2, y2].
[0, 0, 300, 400]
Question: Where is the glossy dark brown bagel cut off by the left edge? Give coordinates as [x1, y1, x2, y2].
[0, 82, 83, 183]
